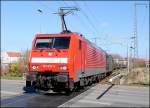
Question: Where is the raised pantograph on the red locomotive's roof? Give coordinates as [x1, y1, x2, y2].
[54, 7, 79, 33]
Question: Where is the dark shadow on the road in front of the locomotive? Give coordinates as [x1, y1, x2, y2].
[1, 84, 98, 107]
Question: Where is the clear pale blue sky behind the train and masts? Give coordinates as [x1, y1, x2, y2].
[1, 1, 149, 58]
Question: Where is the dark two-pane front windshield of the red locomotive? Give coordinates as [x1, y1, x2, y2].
[35, 37, 70, 49]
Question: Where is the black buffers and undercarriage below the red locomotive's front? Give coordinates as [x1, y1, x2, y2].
[26, 72, 74, 91]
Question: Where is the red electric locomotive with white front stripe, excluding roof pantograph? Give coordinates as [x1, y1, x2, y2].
[26, 33, 107, 92]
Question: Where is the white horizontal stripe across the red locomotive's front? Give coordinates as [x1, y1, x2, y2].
[31, 57, 68, 63]
